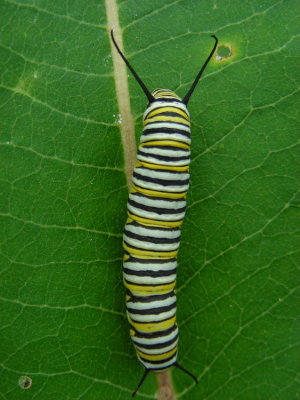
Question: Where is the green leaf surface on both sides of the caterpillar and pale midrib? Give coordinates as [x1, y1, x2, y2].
[0, 0, 300, 400]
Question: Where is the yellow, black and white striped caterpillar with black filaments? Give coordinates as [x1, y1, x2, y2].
[111, 30, 218, 396]
